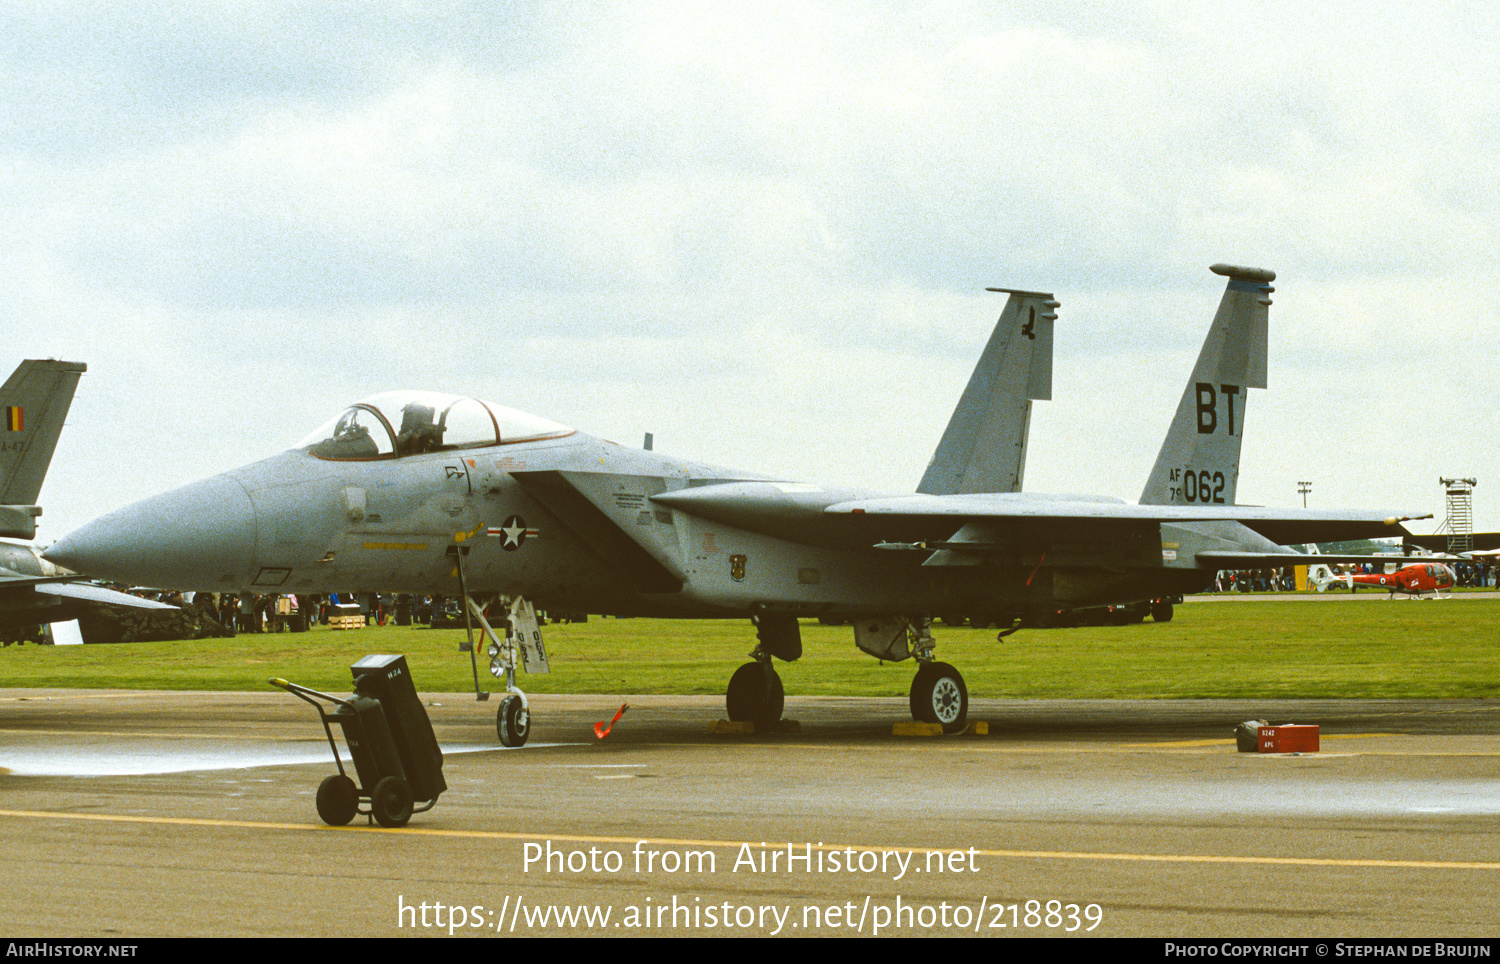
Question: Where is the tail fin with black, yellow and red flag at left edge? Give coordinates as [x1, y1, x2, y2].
[0, 360, 87, 538]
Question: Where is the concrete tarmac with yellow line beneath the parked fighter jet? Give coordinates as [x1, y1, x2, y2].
[0, 690, 1500, 940]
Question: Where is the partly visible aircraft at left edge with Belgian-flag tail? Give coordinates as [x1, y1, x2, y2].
[0, 360, 176, 643]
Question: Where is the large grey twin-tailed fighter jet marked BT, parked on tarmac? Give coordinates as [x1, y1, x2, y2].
[47, 265, 1412, 745]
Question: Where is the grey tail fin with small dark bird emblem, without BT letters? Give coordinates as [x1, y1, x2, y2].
[917, 288, 1058, 495]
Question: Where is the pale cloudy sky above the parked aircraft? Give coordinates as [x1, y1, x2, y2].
[0, 0, 1500, 541]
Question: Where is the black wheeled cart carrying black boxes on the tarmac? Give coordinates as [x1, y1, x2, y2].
[270, 655, 449, 826]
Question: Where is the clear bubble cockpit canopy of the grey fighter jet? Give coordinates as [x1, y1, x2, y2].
[297, 391, 573, 460]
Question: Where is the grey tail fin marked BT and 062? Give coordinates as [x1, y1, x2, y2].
[1140, 264, 1277, 505]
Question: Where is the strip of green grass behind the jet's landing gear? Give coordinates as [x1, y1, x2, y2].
[0, 598, 1500, 699]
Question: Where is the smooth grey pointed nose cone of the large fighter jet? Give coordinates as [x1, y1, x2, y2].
[42, 475, 257, 591]
